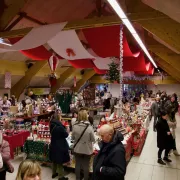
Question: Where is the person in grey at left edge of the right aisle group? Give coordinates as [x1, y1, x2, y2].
[151, 96, 161, 132]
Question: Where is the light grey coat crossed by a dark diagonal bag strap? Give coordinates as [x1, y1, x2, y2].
[72, 121, 95, 155]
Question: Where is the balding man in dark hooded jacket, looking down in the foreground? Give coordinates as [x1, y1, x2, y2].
[93, 125, 126, 180]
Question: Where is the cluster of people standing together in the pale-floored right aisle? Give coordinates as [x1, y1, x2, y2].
[151, 91, 180, 165]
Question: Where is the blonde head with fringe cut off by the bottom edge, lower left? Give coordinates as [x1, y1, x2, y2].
[16, 160, 41, 180]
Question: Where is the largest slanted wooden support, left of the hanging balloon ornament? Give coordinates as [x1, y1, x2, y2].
[11, 61, 47, 99]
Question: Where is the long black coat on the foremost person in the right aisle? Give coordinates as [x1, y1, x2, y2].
[156, 118, 173, 149]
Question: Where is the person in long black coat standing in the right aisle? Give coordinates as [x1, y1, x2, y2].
[156, 111, 173, 165]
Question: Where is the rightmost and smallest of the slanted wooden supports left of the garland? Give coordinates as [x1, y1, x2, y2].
[73, 70, 96, 92]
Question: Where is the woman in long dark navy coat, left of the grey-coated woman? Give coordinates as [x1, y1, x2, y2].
[49, 111, 70, 180]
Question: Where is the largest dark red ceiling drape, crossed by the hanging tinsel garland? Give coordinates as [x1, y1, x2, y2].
[82, 25, 139, 58]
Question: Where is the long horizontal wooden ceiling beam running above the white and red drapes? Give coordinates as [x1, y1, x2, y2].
[0, 11, 168, 38]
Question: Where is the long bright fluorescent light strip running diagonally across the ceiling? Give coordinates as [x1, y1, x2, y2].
[107, 0, 157, 68]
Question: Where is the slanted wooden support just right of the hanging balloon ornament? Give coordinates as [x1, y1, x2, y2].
[51, 67, 76, 93]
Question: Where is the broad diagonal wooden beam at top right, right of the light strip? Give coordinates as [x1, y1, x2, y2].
[126, 0, 180, 52]
